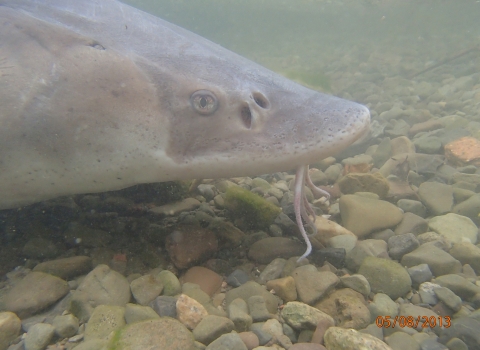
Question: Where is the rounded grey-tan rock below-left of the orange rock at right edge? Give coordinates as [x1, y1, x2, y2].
[418, 182, 453, 215]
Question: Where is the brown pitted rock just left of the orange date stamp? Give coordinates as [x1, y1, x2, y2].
[315, 288, 370, 329]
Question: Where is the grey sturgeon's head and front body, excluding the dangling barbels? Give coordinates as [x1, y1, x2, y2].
[0, 0, 370, 209]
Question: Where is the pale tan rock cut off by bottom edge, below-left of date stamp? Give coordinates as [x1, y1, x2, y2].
[324, 327, 391, 350]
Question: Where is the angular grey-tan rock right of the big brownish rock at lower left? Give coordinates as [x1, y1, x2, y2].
[70, 265, 131, 322]
